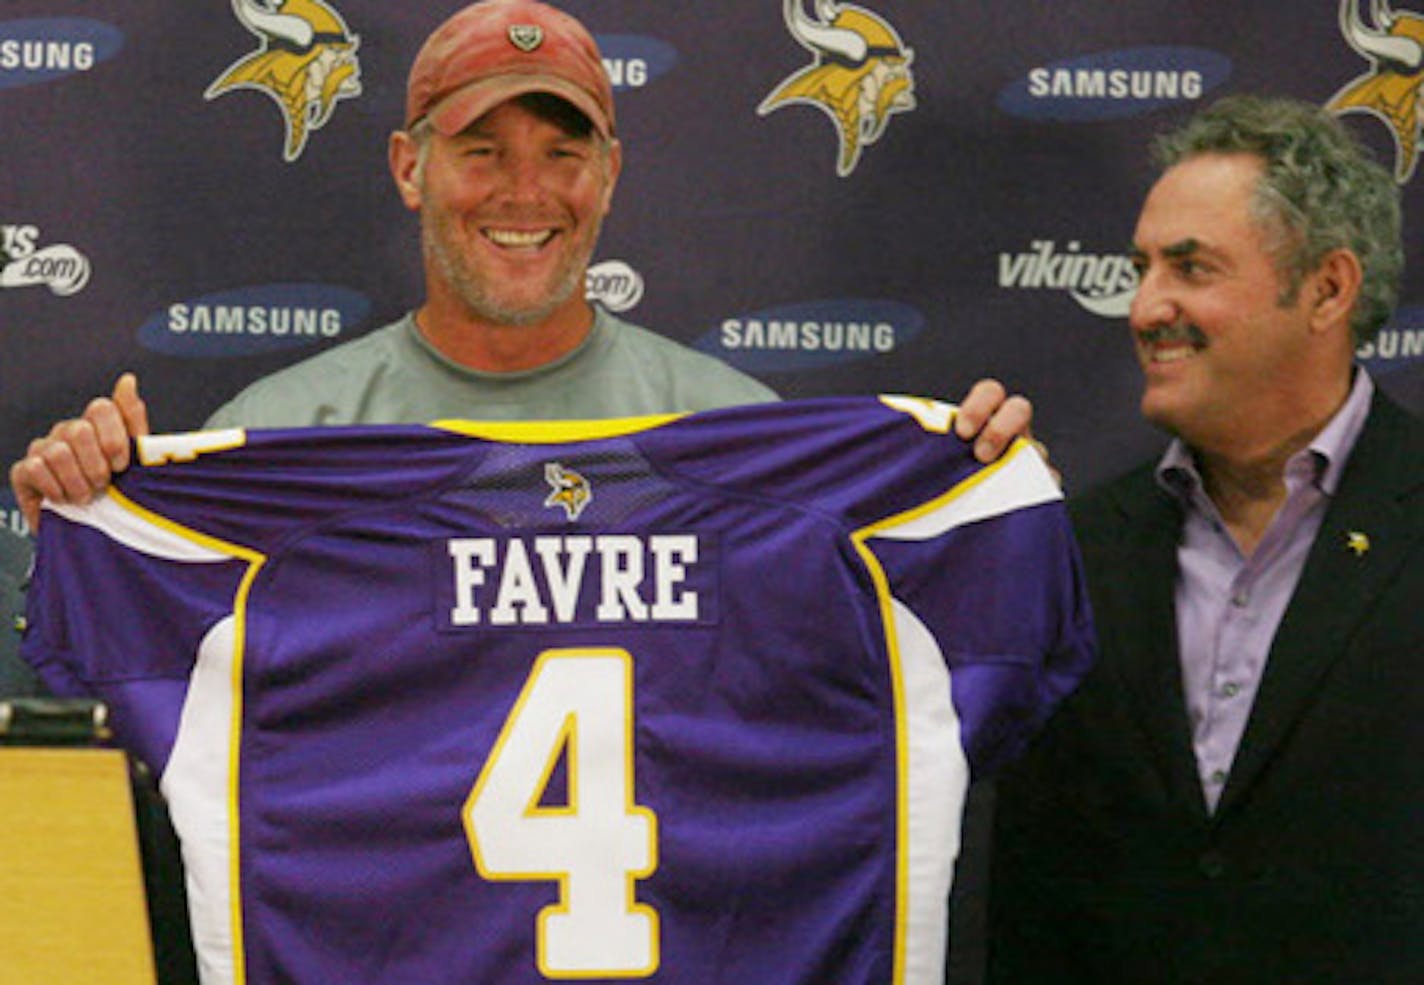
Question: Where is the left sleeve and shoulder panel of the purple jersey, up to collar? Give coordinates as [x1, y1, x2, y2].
[21, 427, 470, 771]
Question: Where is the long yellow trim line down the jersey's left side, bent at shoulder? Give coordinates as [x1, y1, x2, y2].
[108, 487, 266, 985]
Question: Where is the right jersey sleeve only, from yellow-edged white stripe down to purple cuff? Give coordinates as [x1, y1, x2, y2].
[863, 441, 1095, 776]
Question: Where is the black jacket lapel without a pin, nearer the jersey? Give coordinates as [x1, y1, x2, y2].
[1095, 471, 1206, 820]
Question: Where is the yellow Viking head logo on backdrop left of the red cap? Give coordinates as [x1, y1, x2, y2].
[204, 0, 362, 162]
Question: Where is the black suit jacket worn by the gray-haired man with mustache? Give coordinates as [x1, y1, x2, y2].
[990, 396, 1424, 985]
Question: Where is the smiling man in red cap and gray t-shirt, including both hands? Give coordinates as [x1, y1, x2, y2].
[10, 0, 1031, 525]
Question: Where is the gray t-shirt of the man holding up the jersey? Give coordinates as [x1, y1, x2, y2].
[206, 306, 776, 428]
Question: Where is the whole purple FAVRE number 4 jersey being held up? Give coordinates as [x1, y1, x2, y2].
[26, 397, 1091, 985]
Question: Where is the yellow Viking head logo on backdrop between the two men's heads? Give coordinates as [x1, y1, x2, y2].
[756, 0, 916, 178]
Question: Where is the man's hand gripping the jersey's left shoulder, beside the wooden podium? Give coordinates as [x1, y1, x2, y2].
[10, 373, 148, 531]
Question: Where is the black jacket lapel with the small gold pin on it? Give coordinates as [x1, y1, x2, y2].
[1218, 396, 1424, 817]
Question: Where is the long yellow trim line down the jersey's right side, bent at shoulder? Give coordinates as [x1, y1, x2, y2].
[850, 438, 1031, 985]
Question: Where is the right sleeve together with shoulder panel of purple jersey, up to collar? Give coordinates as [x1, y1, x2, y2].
[648, 396, 1095, 774]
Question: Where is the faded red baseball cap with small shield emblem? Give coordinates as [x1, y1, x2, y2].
[406, 0, 614, 138]
